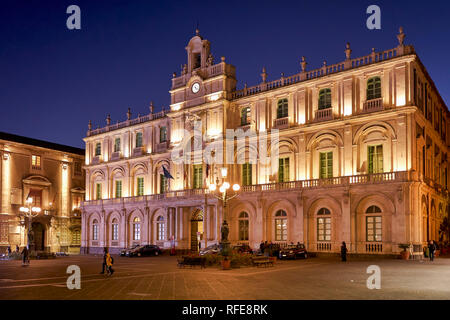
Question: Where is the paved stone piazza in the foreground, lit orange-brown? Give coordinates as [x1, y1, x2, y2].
[0, 255, 450, 300]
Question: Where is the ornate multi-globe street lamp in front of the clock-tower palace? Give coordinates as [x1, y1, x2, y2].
[209, 167, 241, 256]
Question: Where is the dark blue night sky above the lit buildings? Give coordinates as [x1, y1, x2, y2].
[0, 0, 450, 147]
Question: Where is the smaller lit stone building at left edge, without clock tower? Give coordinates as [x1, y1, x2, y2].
[0, 132, 85, 253]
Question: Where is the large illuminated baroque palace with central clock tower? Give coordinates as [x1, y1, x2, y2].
[82, 29, 450, 254]
